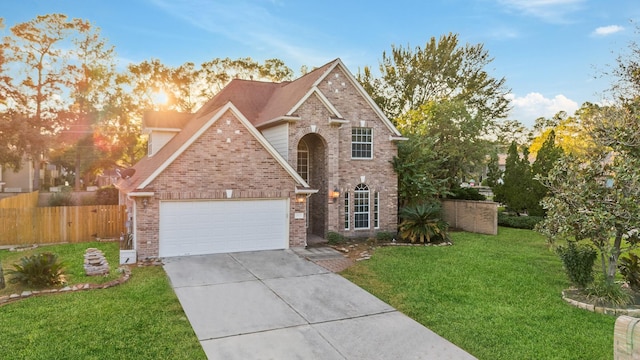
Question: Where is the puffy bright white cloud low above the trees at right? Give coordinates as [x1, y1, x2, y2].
[507, 92, 580, 127]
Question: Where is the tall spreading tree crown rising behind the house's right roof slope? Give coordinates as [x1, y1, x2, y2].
[357, 34, 509, 119]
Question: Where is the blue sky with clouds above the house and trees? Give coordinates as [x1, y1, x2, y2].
[0, 0, 640, 125]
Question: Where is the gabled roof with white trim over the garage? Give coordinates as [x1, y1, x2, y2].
[117, 102, 309, 193]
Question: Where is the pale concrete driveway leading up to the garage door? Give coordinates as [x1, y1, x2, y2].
[164, 250, 474, 360]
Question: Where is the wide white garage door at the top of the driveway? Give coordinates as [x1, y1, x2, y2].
[159, 199, 289, 257]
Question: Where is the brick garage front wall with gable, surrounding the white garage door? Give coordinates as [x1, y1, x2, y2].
[136, 111, 306, 260]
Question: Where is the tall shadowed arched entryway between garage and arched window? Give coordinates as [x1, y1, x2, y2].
[296, 134, 329, 238]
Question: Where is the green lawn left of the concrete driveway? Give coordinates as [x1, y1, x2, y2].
[0, 243, 206, 359]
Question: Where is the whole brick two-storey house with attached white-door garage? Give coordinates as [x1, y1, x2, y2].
[117, 59, 404, 259]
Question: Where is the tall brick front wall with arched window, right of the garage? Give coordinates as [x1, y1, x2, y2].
[288, 67, 398, 237]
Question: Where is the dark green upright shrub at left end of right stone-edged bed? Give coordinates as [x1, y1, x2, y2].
[556, 241, 598, 288]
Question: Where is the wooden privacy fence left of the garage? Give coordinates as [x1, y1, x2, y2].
[0, 205, 127, 246]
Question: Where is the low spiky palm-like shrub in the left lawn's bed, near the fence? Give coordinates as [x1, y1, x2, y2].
[9, 252, 64, 287]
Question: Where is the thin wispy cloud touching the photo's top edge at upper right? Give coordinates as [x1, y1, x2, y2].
[498, 0, 586, 23]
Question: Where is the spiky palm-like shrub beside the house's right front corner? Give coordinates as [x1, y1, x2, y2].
[399, 202, 450, 243]
